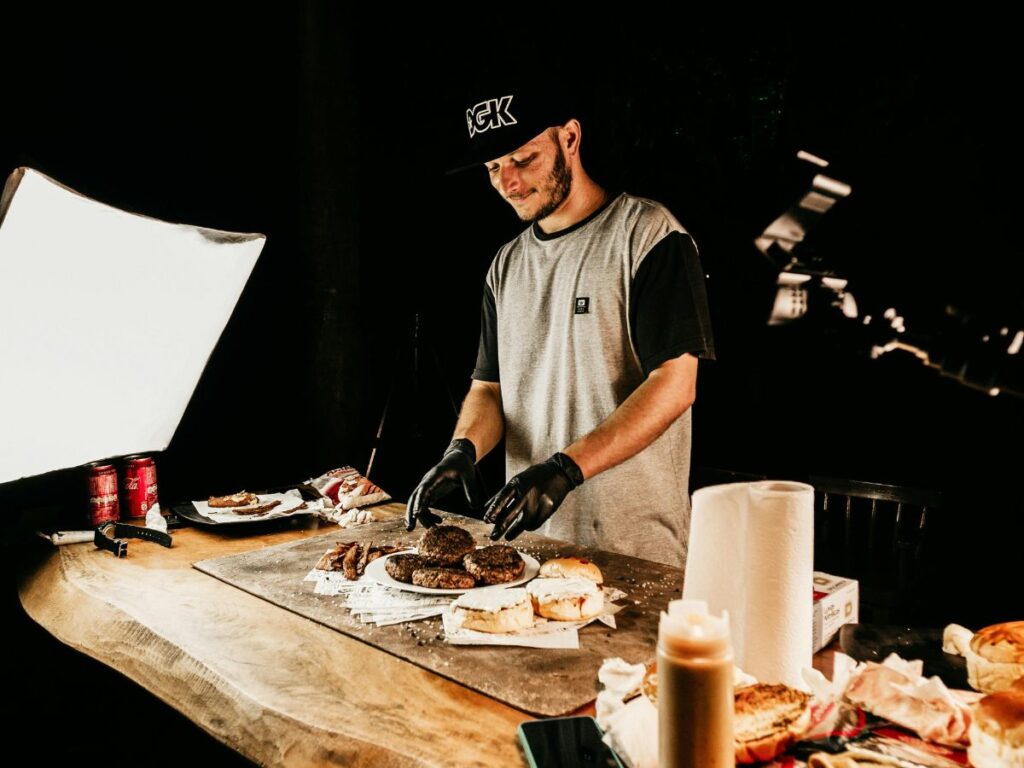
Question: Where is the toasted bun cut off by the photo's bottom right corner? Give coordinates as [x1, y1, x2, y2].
[968, 679, 1024, 768]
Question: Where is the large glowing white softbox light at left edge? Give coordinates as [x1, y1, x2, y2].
[0, 168, 266, 483]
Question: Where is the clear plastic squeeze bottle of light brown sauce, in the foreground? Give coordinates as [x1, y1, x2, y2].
[657, 600, 735, 768]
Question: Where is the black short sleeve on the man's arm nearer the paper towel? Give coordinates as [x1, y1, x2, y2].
[630, 232, 715, 374]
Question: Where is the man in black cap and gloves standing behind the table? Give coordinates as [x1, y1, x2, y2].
[406, 83, 714, 567]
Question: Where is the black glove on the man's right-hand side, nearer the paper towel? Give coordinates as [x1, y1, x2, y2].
[483, 454, 583, 542]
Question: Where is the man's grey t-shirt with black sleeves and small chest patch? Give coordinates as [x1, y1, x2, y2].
[473, 194, 714, 566]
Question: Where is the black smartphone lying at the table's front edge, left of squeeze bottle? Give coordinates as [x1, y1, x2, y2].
[519, 717, 624, 768]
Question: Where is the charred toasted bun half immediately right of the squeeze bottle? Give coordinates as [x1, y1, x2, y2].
[735, 683, 811, 763]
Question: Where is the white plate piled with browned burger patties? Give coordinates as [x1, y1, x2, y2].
[366, 525, 541, 595]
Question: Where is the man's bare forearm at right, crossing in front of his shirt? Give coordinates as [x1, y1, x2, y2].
[563, 354, 697, 478]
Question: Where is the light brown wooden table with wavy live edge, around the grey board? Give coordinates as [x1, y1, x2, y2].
[18, 504, 839, 768]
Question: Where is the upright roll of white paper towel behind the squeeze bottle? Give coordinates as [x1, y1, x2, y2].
[683, 480, 814, 689]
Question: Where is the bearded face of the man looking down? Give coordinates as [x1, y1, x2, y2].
[485, 128, 572, 223]
